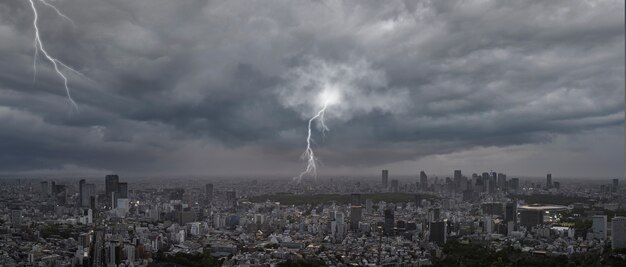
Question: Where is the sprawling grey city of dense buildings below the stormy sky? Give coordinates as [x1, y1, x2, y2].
[0, 173, 626, 266]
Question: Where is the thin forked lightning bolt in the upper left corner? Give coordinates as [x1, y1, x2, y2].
[28, 0, 83, 110]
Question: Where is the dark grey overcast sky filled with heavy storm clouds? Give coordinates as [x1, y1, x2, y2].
[0, 0, 625, 180]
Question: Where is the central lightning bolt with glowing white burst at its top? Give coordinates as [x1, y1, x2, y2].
[294, 87, 341, 183]
